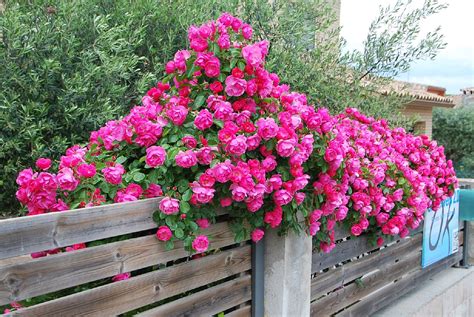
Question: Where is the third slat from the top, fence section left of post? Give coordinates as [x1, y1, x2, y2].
[13, 245, 251, 317]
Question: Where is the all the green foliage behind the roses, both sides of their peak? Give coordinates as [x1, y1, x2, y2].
[0, 0, 446, 214]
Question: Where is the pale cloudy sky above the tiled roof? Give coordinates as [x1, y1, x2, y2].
[341, 0, 474, 94]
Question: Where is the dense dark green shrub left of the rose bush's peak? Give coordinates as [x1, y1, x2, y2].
[0, 0, 225, 214]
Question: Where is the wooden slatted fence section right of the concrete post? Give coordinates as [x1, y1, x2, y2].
[311, 224, 463, 316]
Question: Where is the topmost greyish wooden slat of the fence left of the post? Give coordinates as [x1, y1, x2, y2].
[0, 198, 161, 259]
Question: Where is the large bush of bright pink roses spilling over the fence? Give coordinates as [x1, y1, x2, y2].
[17, 13, 457, 252]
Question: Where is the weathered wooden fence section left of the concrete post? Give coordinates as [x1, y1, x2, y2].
[0, 199, 252, 316]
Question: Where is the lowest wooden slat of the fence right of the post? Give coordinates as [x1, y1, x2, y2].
[336, 248, 462, 317]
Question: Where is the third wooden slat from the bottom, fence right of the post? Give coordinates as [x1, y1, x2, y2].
[311, 234, 422, 300]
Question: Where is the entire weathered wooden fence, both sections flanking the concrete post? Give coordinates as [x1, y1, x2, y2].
[0, 198, 463, 316]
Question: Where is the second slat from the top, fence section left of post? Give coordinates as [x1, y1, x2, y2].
[0, 222, 234, 305]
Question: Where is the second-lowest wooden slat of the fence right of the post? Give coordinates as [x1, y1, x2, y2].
[311, 250, 421, 316]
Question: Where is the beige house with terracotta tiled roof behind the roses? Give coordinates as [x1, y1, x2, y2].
[382, 80, 455, 138]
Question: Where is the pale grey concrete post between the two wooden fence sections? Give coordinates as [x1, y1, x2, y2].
[264, 230, 312, 317]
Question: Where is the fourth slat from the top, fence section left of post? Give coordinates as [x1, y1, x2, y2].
[138, 274, 251, 317]
